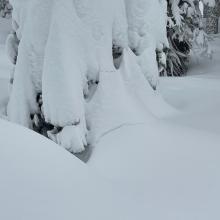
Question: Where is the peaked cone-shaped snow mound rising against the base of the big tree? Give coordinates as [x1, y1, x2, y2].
[87, 49, 177, 143]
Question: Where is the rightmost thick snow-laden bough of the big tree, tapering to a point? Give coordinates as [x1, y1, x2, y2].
[125, 0, 168, 88]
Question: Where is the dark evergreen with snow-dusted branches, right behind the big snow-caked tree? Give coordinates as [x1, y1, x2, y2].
[165, 0, 212, 76]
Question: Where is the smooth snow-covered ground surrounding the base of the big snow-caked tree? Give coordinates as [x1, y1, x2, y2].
[0, 17, 220, 220]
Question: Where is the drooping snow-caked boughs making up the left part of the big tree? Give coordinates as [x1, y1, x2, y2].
[7, 0, 131, 153]
